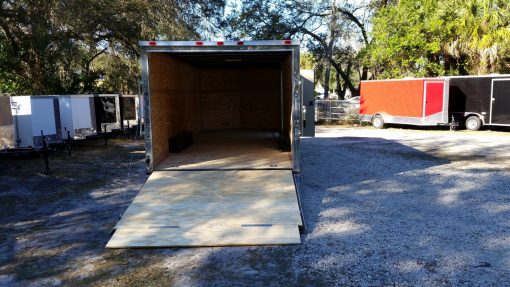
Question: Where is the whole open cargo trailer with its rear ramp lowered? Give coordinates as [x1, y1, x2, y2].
[107, 40, 313, 248]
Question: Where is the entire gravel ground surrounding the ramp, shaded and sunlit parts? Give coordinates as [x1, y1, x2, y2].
[0, 128, 510, 286]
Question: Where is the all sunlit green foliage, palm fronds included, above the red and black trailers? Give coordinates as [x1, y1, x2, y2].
[365, 0, 510, 78]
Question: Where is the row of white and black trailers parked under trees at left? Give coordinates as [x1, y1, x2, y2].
[0, 94, 140, 149]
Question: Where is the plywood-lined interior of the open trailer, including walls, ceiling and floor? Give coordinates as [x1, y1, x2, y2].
[148, 51, 292, 170]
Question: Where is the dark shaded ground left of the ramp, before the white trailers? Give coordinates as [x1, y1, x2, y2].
[0, 139, 151, 286]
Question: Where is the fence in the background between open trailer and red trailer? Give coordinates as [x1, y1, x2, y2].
[315, 98, 359, 121]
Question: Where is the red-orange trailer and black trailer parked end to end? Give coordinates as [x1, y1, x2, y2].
[360, 75, 510, 130]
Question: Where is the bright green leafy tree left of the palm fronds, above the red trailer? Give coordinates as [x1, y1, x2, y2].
[368, 0, 443, 78]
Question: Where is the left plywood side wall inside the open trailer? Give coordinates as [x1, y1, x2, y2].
[149, 53, 201, 169]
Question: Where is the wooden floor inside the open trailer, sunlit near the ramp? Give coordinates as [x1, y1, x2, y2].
[155, 130, 292, 170]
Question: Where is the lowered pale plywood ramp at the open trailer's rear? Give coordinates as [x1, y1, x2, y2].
[106, 170, 302, 248]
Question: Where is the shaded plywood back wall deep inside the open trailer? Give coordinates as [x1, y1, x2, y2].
[200, 66, 281, 131]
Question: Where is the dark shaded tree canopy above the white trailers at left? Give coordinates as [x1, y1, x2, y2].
[0, 0, 224, 94]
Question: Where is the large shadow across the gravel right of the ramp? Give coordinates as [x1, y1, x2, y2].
[185, 137, 510, 286]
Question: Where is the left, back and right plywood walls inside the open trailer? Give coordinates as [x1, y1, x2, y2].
[149, 53, 292, 165]
